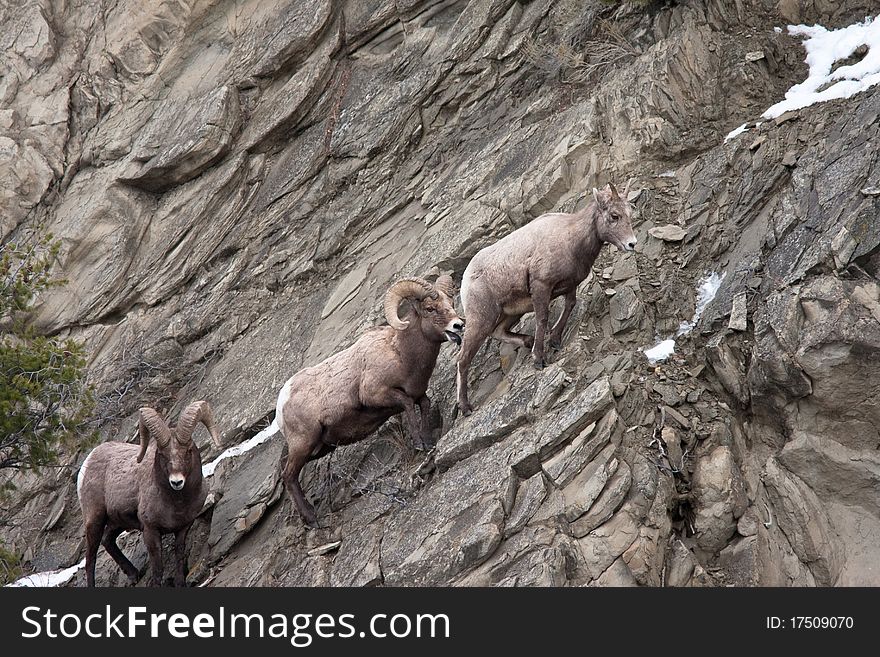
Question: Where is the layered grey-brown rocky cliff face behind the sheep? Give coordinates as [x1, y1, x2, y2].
[0, 0, 880, 586]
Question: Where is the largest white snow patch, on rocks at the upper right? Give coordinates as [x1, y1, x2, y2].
[762, 16, 880, 119]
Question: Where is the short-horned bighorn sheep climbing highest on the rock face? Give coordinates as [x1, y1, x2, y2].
[456, 183, 636, 415]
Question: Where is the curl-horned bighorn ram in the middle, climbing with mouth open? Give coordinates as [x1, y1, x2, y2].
[275, 276, 464, 527]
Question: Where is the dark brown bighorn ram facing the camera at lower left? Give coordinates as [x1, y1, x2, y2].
[76, 401, 220, 586]
